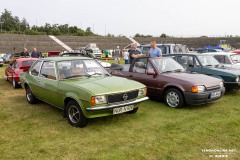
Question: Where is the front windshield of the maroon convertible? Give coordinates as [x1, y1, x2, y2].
[151, 58, 184, 73]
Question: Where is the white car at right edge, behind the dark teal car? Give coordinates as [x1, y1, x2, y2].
[203, 52, 240, 70]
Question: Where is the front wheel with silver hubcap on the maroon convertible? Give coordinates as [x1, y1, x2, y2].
[164, 88, 184, 108]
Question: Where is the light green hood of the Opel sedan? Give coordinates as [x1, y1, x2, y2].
[62, 76, 145, 95]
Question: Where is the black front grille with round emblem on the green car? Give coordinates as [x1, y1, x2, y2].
[108, 90, 138, 103]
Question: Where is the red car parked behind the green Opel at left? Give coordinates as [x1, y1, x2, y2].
[5, 58, 38, 88]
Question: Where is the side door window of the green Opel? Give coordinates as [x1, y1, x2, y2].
[40, 61, 56, 80]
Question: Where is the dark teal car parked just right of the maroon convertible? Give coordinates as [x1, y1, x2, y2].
[164, 53, 240, 90]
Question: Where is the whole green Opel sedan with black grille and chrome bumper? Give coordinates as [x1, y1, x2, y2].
[20, 57, 148, 127]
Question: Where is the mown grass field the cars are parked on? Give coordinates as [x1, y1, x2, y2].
[0, 63, 240, 160]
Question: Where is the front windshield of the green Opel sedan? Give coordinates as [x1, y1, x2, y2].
[57, 59, 109, 80]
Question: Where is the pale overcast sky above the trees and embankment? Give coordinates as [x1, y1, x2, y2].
[0, 0, 240, 36]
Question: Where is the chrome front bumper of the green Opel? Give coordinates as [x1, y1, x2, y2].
[86, 97, 149, 111]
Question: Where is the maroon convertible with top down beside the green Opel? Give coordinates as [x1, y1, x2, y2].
[110, 57, 225, 108]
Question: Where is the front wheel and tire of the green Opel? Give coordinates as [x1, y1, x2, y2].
[66, 100, 88, 128]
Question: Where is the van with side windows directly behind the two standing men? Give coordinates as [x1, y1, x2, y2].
[139, 43, 189, 55]
